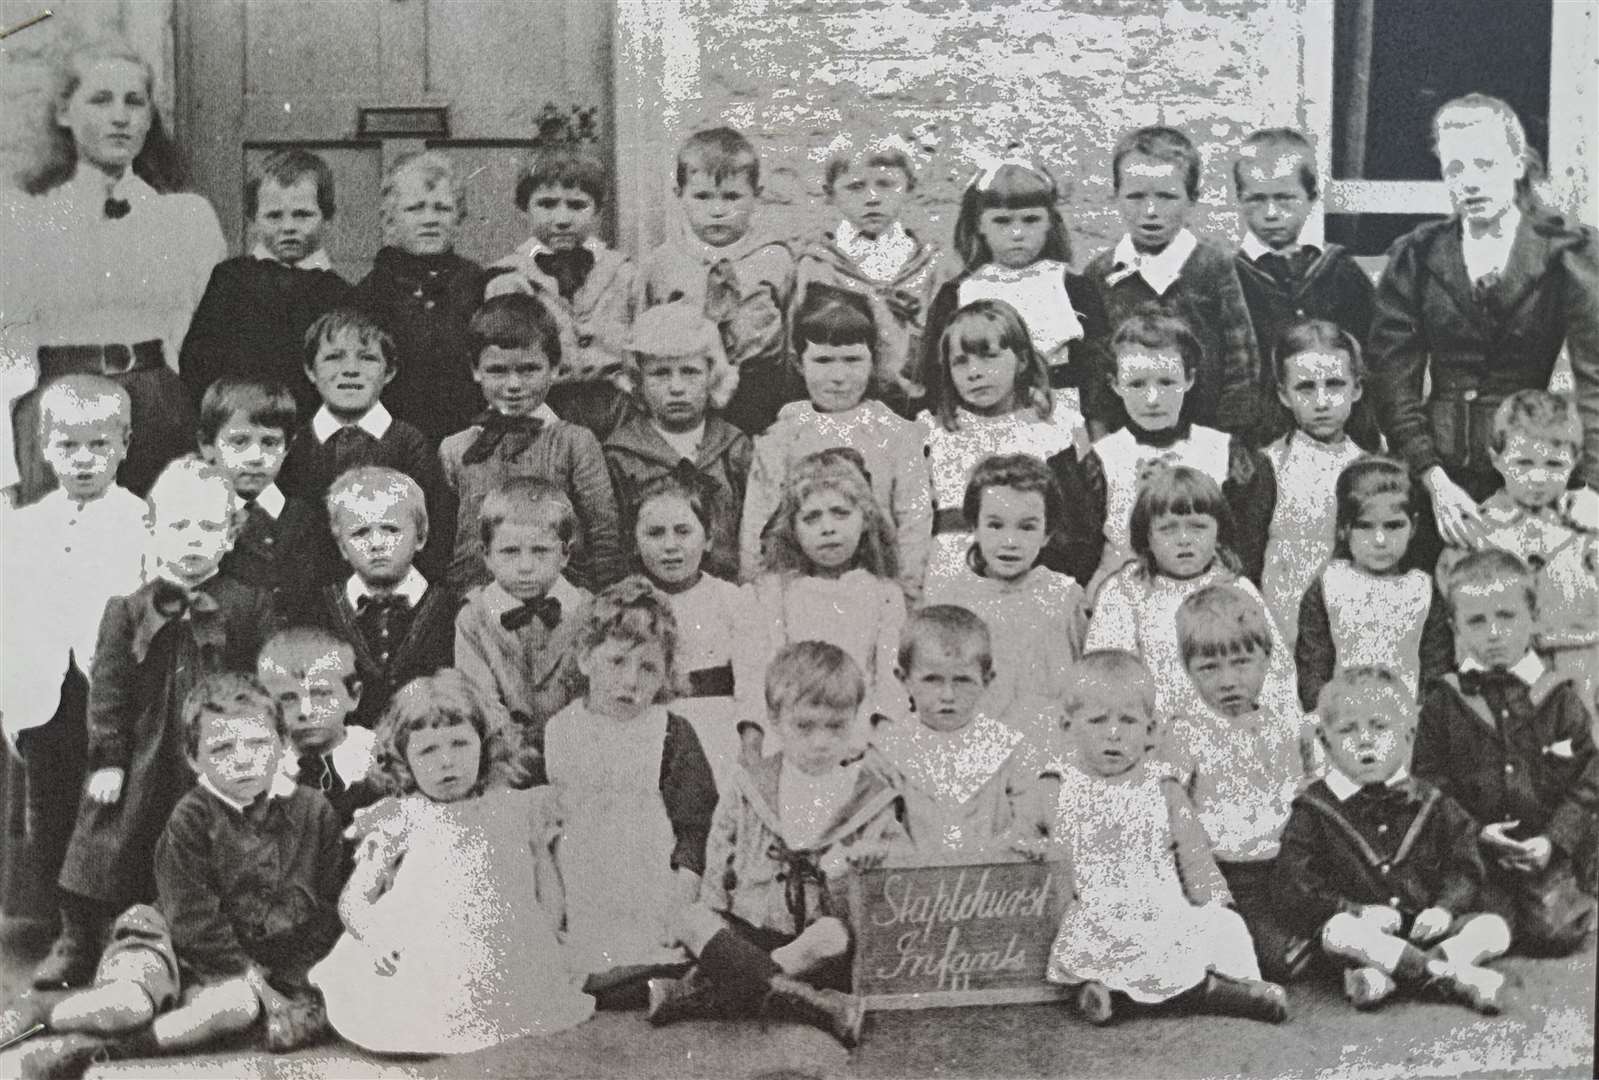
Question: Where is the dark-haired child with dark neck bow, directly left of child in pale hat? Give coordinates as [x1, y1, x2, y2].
[438, 293, 622, 590]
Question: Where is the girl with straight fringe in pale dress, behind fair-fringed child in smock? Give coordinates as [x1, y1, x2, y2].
[1084, 466, 1294, 720]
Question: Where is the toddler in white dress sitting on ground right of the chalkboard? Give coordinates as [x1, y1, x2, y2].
[1047, 650, 1289, 1024]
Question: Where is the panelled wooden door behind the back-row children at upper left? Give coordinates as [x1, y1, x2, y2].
[174, 0, 614, 282]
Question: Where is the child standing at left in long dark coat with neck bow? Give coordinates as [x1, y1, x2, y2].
[34, 458, 273, 989]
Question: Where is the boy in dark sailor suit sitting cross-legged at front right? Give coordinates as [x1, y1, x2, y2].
[1274, 664, 1509, 1013]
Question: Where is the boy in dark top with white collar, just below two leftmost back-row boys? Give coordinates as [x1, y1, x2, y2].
[280, 307, 456, 584]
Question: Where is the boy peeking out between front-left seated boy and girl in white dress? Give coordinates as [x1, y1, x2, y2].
[256, 626, 382, 829]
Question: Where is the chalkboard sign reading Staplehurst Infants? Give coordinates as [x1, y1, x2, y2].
[849, 861, 1071, 1010]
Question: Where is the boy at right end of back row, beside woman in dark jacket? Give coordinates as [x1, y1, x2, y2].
[1233, 128, 1378, 450]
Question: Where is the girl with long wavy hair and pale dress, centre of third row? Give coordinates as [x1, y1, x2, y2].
[732, 450, 907, 760]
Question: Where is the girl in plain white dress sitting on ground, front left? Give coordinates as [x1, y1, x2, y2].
[310, 670, 593, 1054]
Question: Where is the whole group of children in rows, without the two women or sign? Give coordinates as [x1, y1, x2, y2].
[0, 97, 1599, 1075]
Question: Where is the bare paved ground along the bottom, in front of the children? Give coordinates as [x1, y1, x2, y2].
[0, 934, 1596, 1080]
